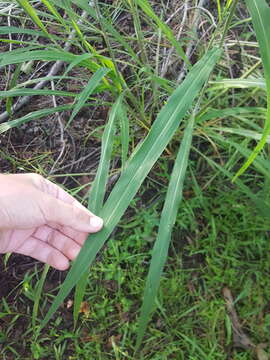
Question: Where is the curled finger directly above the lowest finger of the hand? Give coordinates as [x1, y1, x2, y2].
[32, 226, 81, 260]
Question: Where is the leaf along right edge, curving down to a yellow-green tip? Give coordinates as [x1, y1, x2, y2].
[233, 0, 270, 181]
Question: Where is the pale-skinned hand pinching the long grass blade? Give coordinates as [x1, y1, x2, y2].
[0, 174, 103, 270]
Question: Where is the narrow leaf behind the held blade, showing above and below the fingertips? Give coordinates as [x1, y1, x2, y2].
[73, 95, 122, 326]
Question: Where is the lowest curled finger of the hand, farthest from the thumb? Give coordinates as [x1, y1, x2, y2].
[16, 237, 69, 270]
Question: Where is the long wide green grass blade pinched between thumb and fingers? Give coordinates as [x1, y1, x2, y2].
[41, 48, 221, 328]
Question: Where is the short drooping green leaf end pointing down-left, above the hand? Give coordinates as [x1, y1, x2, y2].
[66, 68, 110, 127]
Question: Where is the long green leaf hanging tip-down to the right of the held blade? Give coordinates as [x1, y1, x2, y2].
[136, 112, 194, 350]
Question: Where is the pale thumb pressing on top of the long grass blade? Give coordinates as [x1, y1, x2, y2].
[41, 195, 103, 233]
